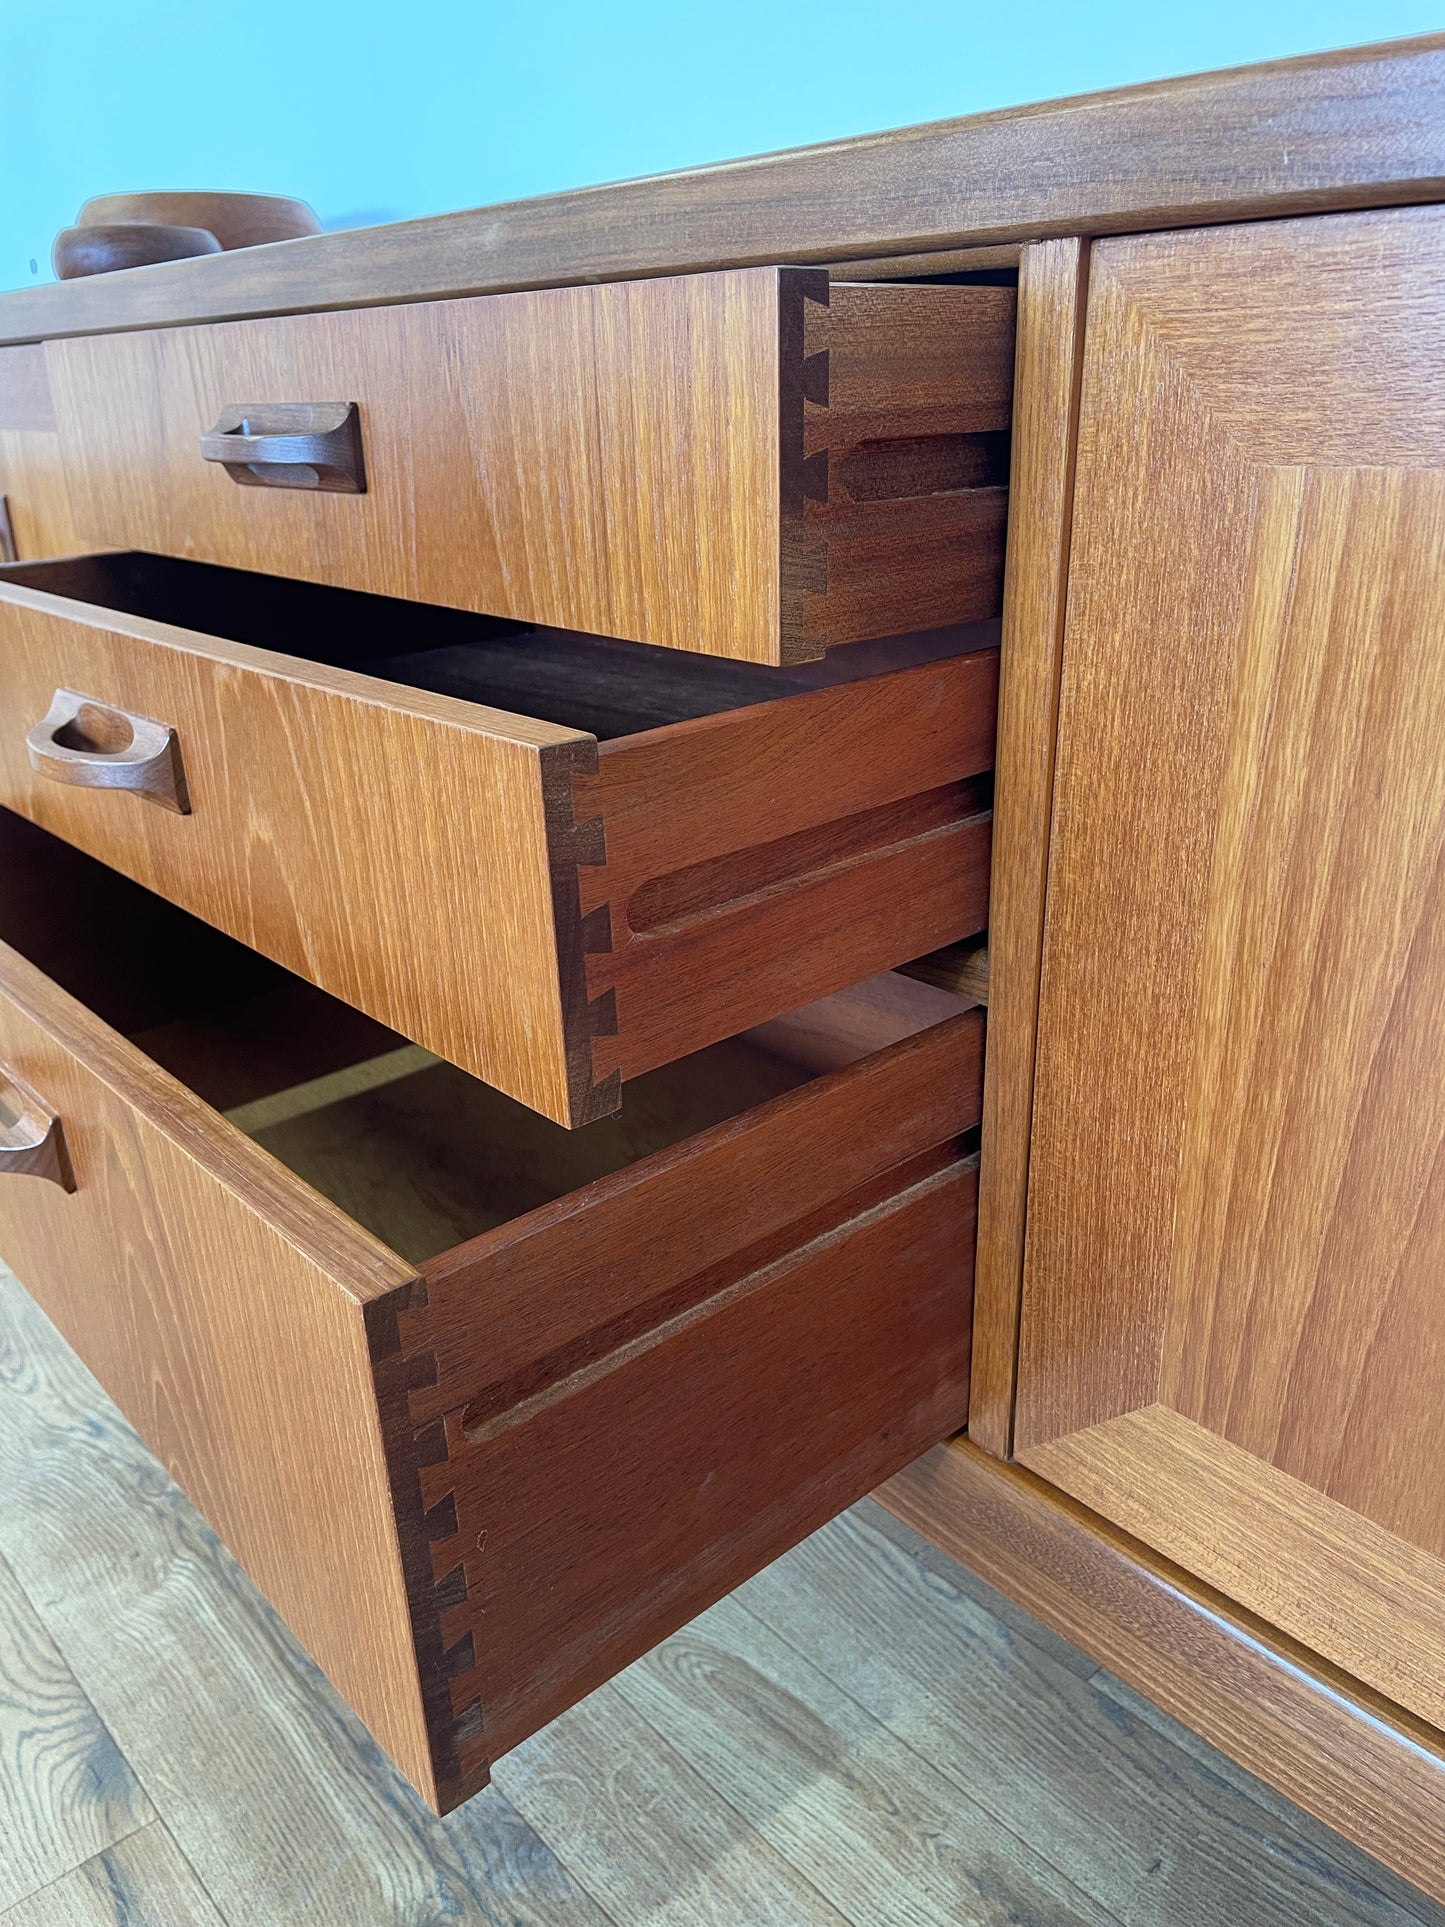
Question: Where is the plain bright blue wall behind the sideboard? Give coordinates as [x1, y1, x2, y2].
[0, 0, 1439, 287]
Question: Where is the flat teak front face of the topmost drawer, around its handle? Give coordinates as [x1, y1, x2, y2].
[46, 268, 793, 661]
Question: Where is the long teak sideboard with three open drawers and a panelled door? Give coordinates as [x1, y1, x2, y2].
[0, 37, 1445, 1898]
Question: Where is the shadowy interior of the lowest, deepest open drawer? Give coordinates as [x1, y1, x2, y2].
[0, 811, 978, 1264]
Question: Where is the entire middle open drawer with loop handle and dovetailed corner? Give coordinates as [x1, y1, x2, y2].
[0, 555, 998, 1125]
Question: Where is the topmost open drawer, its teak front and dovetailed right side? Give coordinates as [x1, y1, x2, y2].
[46, 268, 1013, 663]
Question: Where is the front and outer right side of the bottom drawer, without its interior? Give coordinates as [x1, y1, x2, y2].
[0, 892, 983, 1809]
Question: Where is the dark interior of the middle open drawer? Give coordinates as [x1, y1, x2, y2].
[0, 551, 998, 742]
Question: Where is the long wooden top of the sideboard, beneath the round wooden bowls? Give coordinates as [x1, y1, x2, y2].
[0, 35, 1445, 341]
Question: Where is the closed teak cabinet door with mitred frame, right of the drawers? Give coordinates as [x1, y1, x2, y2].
[1015, 208, 1445, 1725]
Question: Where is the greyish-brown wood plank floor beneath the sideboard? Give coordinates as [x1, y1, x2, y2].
[0, 1274, 1445, 1927]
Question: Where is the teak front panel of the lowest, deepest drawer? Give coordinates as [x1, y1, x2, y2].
[0, 946, 430, 1784]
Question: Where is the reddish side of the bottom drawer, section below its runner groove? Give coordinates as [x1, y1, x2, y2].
[378, 1150, 977, 1809]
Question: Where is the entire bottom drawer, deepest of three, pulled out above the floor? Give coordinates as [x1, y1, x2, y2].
[0, 811, 983, 1808]
